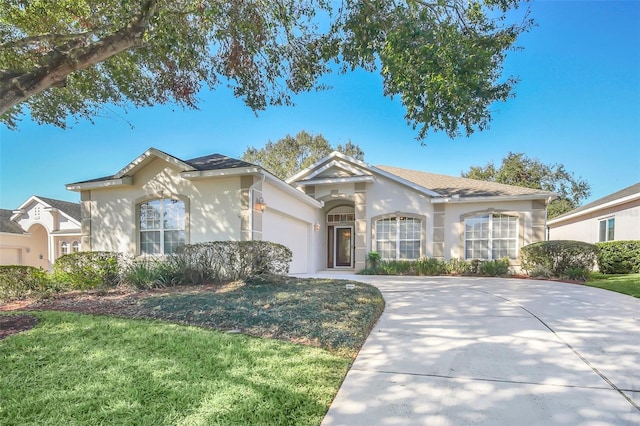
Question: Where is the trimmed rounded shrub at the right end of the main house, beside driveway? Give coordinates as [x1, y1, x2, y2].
[520, 240, 596, 278]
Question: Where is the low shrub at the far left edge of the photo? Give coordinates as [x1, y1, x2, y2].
[0, 265, 58, 301]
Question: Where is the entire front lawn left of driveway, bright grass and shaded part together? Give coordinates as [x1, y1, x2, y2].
[0, 280, 384, 425]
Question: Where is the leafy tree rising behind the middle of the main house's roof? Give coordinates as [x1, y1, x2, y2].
[242, 130, 364, 179]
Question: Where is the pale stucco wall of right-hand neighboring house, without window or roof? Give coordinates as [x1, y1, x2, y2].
[549, 200, 640, 244]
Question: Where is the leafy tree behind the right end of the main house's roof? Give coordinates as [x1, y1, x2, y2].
[461, 152, 591, 218]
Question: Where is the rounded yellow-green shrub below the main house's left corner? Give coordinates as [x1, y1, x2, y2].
[53, 251, 123, 290]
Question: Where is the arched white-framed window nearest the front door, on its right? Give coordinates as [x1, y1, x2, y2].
[375, 216, 422, 260]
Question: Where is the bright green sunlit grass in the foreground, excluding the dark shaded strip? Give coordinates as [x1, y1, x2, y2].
[0, 312, 350, 424]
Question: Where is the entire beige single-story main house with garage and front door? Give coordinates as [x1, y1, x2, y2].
[67, 148, 556, 273]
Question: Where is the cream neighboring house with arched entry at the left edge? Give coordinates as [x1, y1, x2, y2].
[0, 196, 81, 270]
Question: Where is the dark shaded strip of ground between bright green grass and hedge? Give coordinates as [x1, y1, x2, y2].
[0, 279, 384, 358]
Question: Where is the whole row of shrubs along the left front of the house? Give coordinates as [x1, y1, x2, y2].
[0, 241, 292, 300]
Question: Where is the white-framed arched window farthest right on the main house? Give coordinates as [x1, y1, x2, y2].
[464, 214, 518, 260]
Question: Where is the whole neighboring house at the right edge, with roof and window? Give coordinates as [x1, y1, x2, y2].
[547, 182, 640, 243]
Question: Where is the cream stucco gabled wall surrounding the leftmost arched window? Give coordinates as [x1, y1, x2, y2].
[83, 159, 242, 255]
